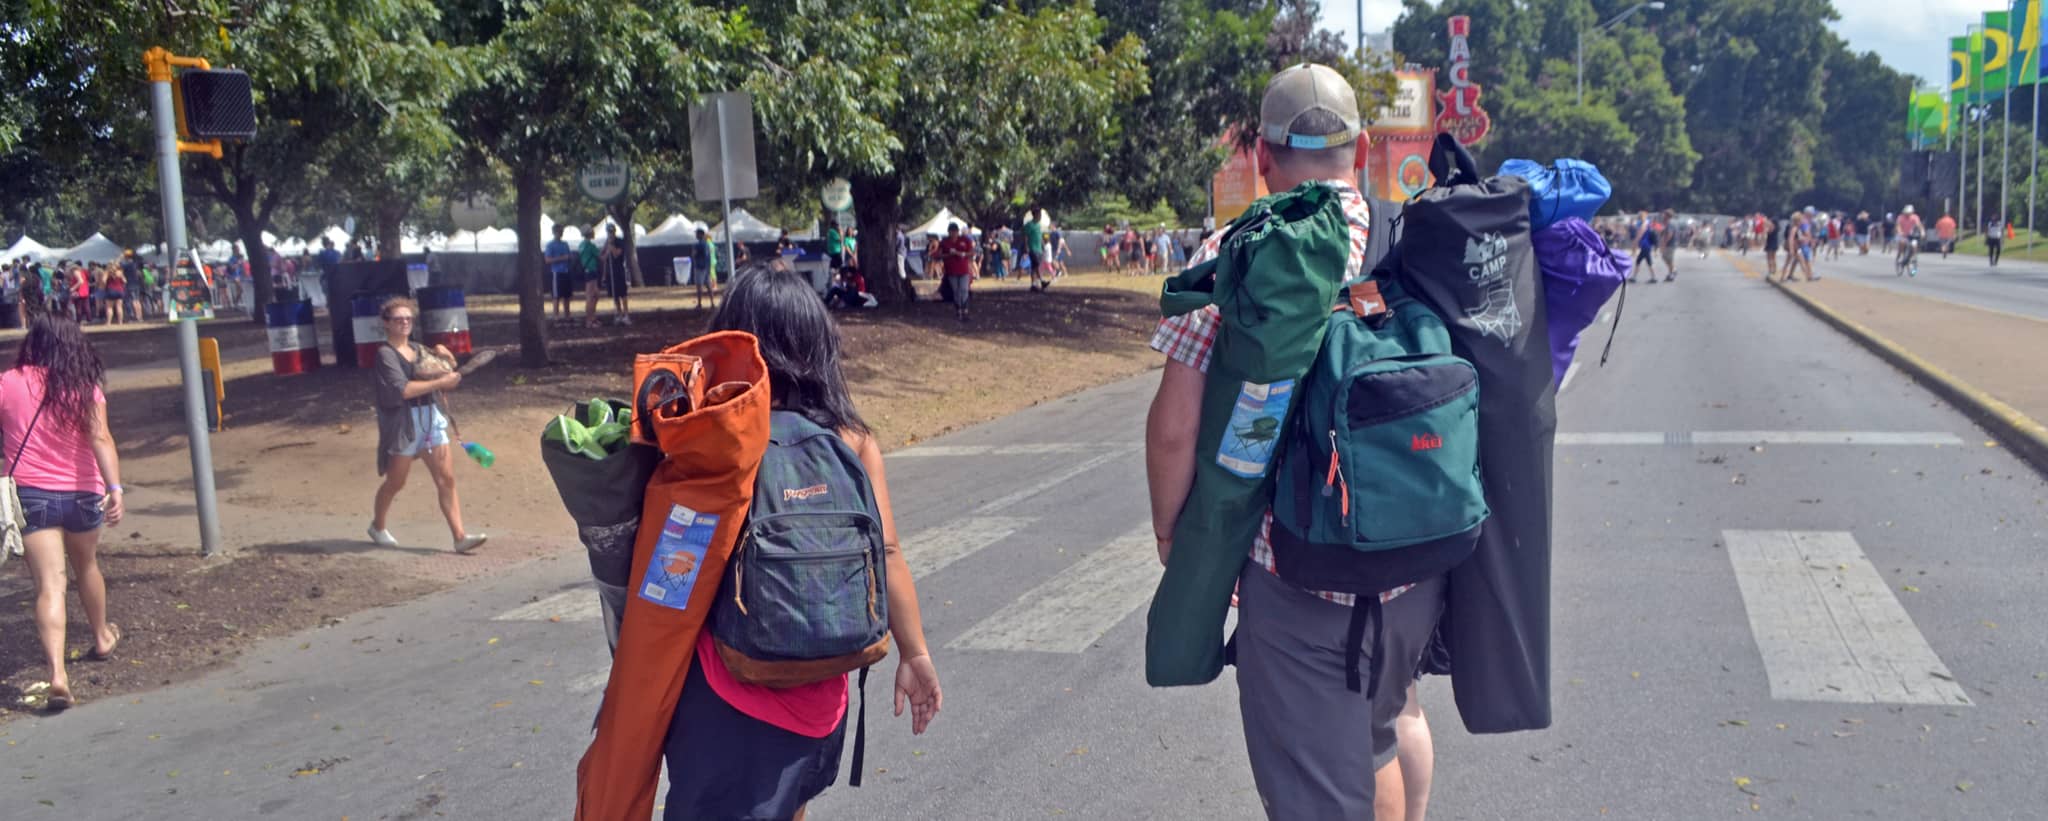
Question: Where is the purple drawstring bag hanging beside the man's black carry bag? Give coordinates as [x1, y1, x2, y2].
[1530, 217, 1630, 383]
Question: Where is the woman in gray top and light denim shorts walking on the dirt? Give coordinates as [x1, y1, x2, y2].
[371, 297, 489, 553]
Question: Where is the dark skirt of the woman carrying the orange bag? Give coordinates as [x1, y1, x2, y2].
[662, 651, 846, 821]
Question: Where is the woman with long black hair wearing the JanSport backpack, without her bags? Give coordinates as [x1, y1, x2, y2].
[666, 262, 940, 821]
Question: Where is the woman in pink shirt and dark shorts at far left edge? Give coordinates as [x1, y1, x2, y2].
[0, 315, 121, 710]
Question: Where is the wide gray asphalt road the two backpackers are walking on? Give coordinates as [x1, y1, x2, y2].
[0, 258, 2048, 819]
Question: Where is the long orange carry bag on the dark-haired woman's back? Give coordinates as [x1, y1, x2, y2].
[575, 332, 768, 821]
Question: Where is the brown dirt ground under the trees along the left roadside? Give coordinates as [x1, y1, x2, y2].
[0, 274, 1157, 721]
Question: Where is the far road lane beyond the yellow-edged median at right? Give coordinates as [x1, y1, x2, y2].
[1785, 239, 2048, 319]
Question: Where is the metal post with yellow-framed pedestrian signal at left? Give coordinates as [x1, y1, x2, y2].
[143, 47, 235, 557]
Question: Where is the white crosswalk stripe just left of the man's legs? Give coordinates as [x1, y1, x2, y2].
[946, 524, 1161, 653]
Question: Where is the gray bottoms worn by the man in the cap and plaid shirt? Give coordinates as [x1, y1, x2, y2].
[1237, 563, 1444, 819]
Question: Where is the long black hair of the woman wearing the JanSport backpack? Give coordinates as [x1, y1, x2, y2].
[709, 262, 868, 434]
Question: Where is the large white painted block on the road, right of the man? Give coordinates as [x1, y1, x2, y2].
[1722, 530, 1970, 704]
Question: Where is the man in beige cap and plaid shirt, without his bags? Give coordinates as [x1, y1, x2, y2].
[1145, 63, 1444, 819]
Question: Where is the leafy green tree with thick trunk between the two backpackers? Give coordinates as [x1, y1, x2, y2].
[748, 0, 1145, 303]
